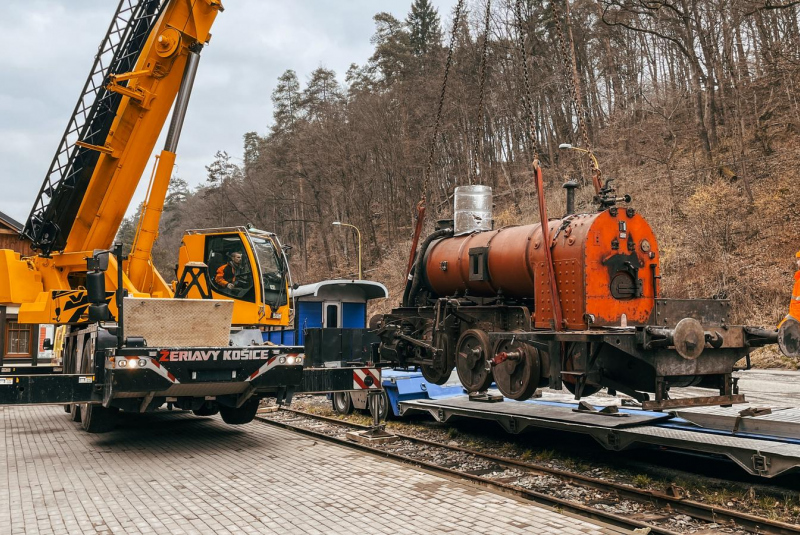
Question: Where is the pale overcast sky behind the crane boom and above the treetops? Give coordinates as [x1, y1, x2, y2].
[0, 0, 455, 223]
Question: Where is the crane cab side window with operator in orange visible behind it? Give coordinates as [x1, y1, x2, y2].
[206, 234, 256, 302]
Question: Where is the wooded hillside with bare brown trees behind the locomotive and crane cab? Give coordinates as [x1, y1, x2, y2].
[128, 0, 800, 364]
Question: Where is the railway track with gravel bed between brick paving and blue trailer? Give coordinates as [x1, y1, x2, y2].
[258, 409, 800, 535]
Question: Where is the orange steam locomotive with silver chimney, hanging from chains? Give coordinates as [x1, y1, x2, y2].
[378, 186, 777, 409]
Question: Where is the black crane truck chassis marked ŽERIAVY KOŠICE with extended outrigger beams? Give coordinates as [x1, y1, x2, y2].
[0, 244, 381, 432]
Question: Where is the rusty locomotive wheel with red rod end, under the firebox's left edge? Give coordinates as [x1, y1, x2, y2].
[492, 340, 541, 401]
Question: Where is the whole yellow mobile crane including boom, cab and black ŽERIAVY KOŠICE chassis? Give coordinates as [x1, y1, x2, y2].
[0, 0, 380, 431]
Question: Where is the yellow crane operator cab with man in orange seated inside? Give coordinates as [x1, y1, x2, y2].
[177, 227, 290, 326]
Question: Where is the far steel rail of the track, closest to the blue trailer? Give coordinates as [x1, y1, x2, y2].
[268, 408, 800, 535]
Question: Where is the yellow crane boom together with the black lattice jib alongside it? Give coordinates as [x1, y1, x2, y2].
[23, 0, 222, 256]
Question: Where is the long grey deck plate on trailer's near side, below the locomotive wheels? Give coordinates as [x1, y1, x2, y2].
[401, 396, 672, 429]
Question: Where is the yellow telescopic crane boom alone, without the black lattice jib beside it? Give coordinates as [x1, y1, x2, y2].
[65, 0, 222, 258]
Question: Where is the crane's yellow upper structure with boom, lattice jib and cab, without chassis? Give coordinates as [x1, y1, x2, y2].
[0, 0, 289, 326]
